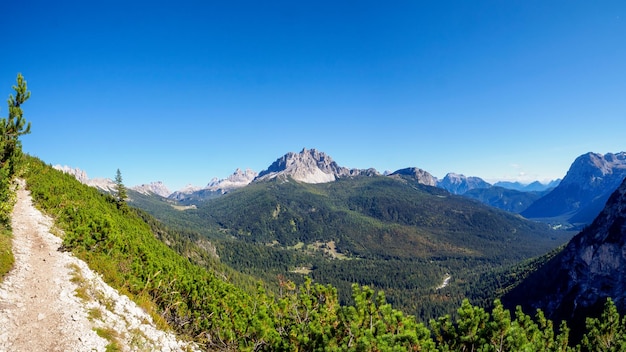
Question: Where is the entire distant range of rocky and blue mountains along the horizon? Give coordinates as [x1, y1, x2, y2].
[57, 149, 626, 228]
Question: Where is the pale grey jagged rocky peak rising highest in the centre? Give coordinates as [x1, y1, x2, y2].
[255, 149, 379, 183]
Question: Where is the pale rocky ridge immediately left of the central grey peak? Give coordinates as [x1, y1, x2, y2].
[168, 169, 257, 205]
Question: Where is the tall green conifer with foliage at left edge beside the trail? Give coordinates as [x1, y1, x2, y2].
[0, 73, 30, 279]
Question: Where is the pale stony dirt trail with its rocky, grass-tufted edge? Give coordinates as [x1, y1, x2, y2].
[0, 183, 193, 351]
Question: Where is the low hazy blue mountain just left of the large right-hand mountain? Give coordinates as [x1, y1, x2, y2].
[463, 186, 545, 213]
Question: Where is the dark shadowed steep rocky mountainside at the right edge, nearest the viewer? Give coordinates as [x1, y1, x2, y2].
[505, 176, 626, 336]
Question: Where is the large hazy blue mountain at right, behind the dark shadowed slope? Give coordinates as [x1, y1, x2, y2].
[522, 152, 626, 225]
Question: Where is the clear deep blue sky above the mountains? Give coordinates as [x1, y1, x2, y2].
[0, 0, 626, 190]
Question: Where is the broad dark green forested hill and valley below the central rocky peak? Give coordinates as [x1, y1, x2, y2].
[131, 177, 572, 322]
